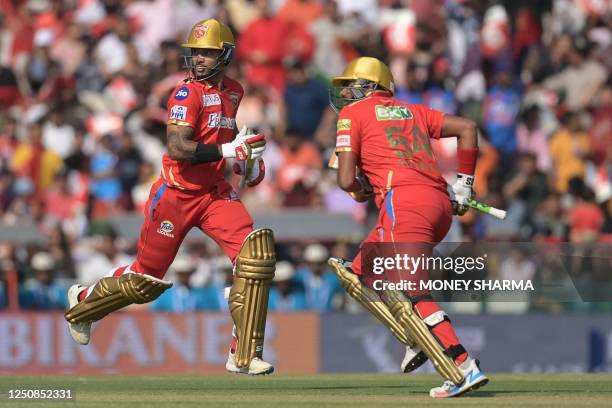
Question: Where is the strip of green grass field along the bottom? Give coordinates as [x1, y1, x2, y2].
[0, 374, 612, 408]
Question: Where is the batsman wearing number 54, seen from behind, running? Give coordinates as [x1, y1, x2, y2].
[329, 57, 488, 398]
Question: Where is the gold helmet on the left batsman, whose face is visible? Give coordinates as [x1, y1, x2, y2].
[182, 18, 236, 81]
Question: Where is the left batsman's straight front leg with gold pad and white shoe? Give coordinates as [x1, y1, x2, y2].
[200, 183, 276, 375]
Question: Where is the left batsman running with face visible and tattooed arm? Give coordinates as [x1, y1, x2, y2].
[65, 19, 275, 375]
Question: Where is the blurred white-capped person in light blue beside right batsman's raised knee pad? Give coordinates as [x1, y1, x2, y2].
[295, 244, 344, 312]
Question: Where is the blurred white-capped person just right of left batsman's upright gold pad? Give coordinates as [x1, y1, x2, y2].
[268, 261, 307, 312]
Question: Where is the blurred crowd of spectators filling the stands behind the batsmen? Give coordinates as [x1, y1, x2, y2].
[0, 0, 612, 310]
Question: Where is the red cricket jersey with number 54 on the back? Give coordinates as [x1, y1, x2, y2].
[336, 92, 448, 206]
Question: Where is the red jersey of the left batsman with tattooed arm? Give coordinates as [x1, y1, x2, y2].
[162, 77, 244, 190]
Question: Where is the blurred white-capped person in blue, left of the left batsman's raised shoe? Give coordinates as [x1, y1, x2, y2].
[19, 252, 68, 310]
